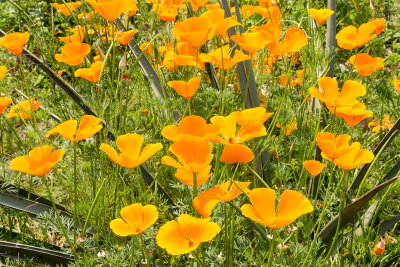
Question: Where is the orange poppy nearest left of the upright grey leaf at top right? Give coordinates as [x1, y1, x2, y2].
[267, 27, 308, 55]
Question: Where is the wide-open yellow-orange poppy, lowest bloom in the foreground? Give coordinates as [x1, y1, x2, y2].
[156, 214, 221, 255]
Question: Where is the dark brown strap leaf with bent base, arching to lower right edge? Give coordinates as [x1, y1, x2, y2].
[318, 177, 398, 248]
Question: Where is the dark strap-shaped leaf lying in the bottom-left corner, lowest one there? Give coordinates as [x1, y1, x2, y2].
[0, 241, 74, 266]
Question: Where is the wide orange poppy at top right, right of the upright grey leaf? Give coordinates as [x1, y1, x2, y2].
[336, 20, 385, 50]
